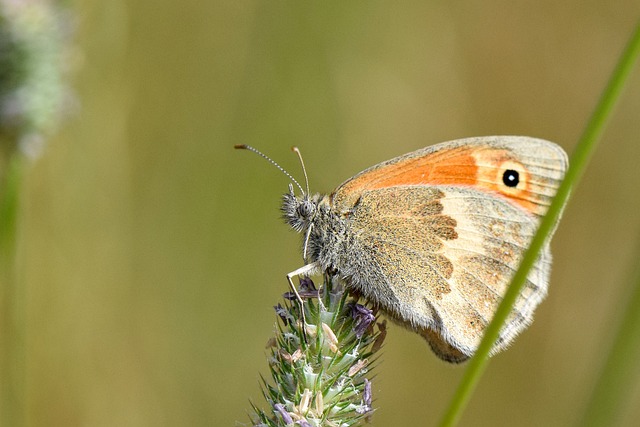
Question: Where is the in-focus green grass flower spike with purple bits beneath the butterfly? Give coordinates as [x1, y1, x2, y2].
[252, 275, 386, 427]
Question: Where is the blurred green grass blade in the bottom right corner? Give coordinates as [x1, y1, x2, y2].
[579, 241, 640, 427]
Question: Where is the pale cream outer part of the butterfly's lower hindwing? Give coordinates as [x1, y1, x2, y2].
[442, 187, 551, 352]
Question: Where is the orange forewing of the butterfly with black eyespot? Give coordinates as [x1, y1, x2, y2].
[332, 136, 568, 216]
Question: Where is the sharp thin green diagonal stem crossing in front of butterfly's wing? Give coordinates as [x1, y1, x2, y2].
[440, 23, 640, 427]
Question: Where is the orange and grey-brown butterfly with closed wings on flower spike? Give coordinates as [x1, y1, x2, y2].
[238, 136, 568, 363]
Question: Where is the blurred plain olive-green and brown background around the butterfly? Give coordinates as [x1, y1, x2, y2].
[8, 0, 640, 426]
